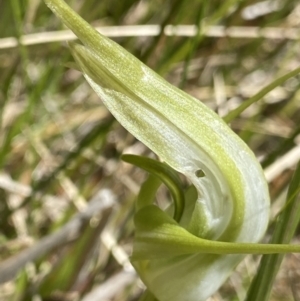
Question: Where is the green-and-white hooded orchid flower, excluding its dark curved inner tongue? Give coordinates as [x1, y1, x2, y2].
[45, 0, 300, 301]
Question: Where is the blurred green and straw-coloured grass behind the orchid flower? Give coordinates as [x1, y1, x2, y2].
[0, 0, 300, 301]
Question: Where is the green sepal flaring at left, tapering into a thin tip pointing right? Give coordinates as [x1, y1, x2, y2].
[132, 205, 300, 261]
